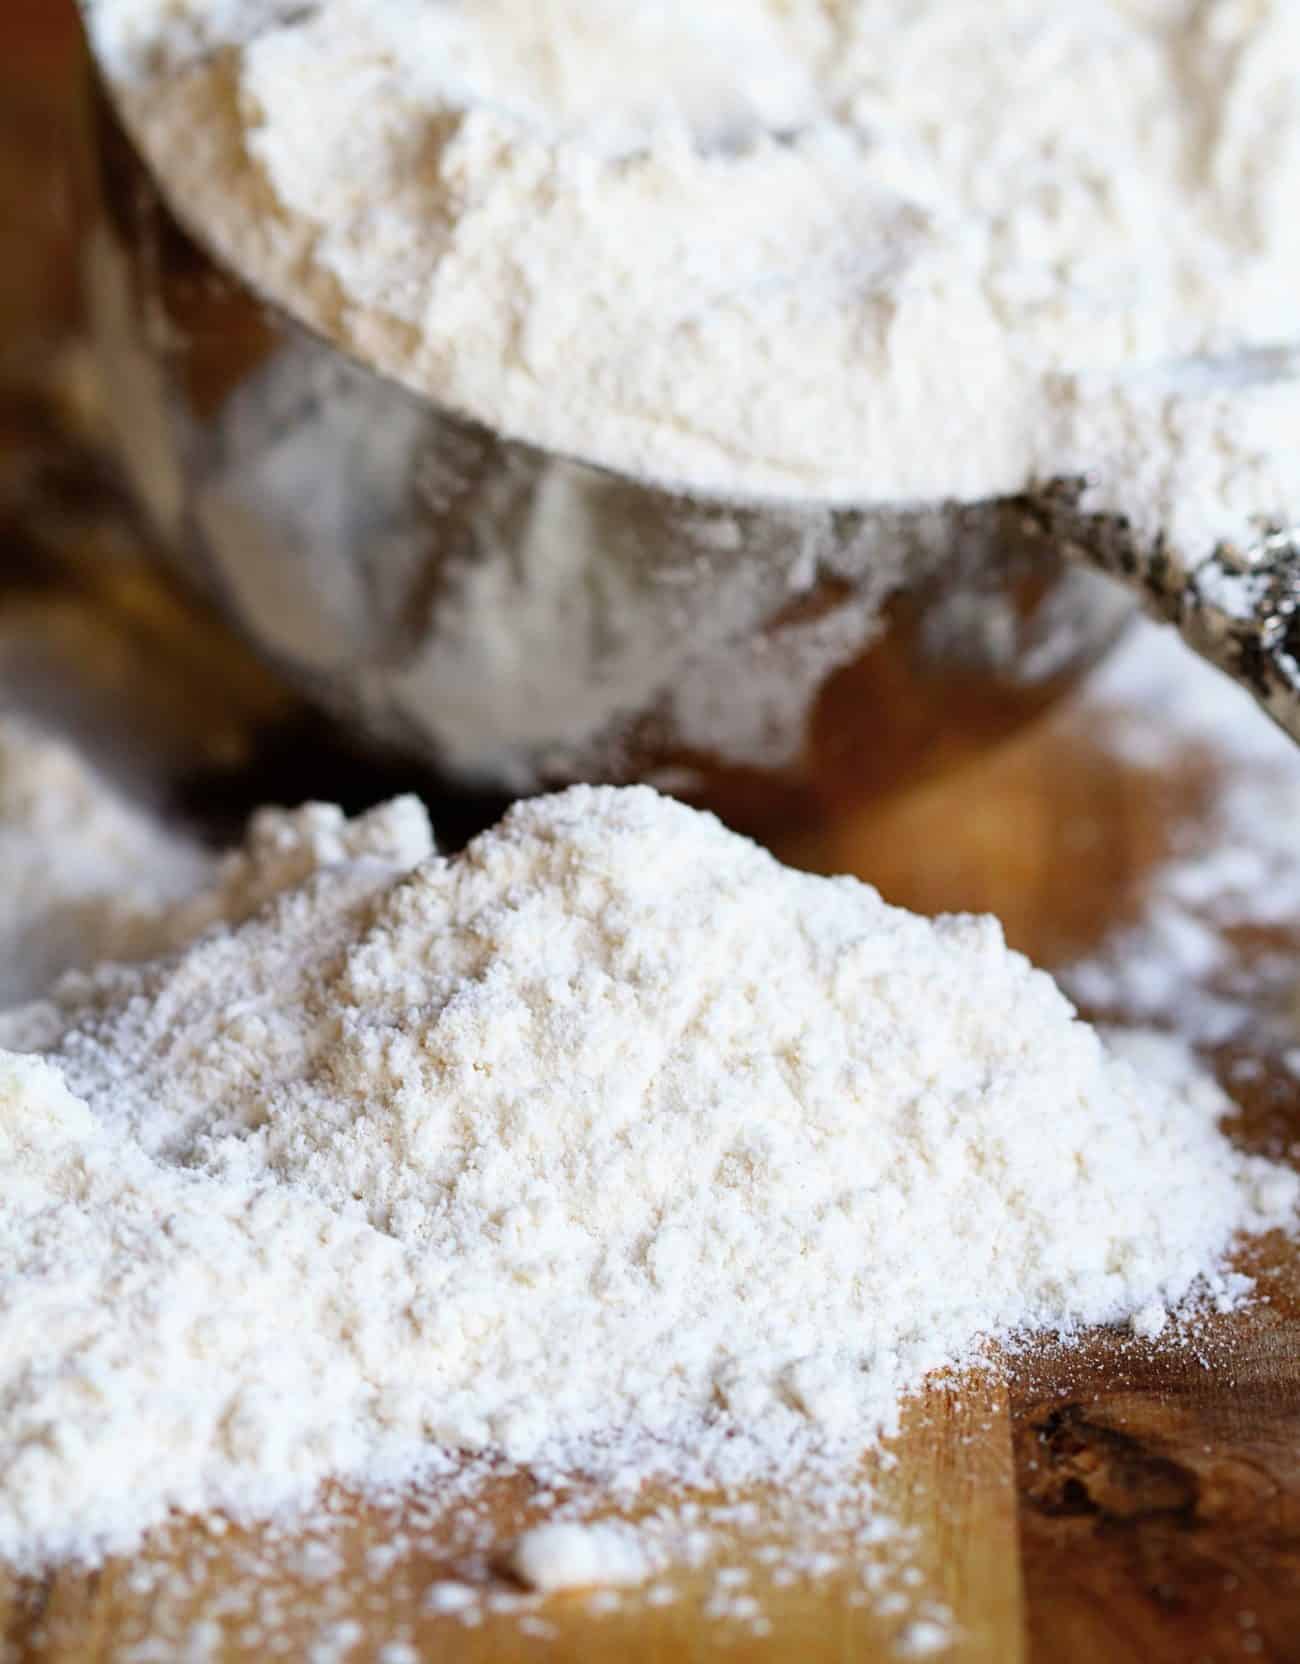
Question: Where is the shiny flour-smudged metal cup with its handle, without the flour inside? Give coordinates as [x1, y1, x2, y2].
[88, 73, 1300, 827]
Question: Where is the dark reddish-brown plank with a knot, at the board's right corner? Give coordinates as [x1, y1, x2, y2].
[1014, 1260, 1300, 1664]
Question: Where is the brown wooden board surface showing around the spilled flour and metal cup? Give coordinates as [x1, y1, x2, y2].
[0, 0, 1300, 1664]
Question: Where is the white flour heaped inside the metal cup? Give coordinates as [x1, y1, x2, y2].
[87, 0, 1300, 554]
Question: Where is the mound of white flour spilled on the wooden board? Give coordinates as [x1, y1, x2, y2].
[0, 787, 1297, 1564]
